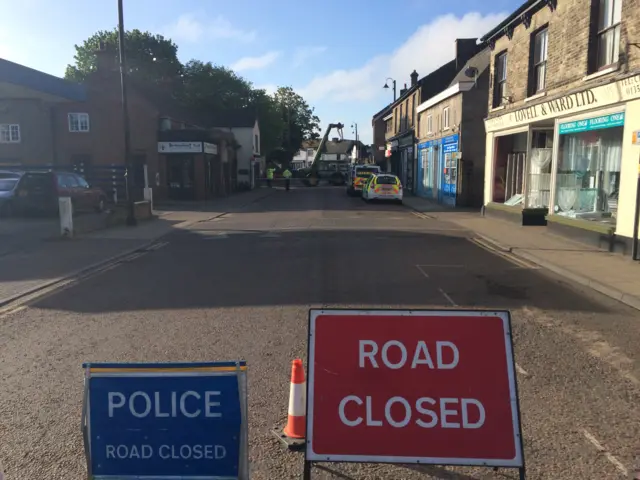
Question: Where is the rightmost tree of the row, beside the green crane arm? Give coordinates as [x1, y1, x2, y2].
[274, 87, 320, 155]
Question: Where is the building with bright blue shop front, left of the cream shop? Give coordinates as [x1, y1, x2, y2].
[416, 47, 490, 207]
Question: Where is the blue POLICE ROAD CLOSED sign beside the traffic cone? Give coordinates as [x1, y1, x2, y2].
[83, 362, 248, 480]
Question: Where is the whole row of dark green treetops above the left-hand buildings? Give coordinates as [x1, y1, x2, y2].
[65, 29, 320, 158]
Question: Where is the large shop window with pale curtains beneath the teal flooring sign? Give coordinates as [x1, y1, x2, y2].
[554, 127, 623, 222]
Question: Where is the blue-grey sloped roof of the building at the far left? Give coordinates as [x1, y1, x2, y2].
[0, 58, 87, 102]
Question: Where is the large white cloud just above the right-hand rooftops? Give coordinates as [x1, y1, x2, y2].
[299, 12, 507, 101]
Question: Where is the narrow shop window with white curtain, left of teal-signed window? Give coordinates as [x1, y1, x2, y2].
[525, 129, 553, 208]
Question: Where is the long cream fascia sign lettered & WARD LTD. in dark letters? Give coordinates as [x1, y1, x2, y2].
[485, 83, 621, 132]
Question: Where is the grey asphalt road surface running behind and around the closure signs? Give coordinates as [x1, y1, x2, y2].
[0, 188, 640, 480]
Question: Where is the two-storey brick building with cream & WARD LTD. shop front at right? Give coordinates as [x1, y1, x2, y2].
[483, 0, 640, 255]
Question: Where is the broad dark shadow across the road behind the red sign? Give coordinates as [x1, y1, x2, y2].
[32, 229, 608, 313]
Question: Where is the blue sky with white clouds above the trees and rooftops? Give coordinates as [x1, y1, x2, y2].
[0, 0, 521, 143]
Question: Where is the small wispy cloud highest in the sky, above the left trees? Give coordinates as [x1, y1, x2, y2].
[163, 13, 257, 43]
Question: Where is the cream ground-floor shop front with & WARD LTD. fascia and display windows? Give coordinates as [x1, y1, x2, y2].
[484, 76, 640, 251]
